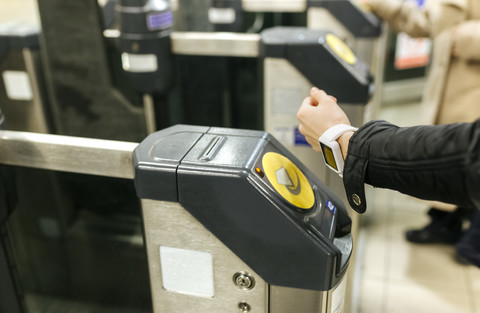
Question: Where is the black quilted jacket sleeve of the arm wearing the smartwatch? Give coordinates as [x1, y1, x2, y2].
[343, 120, 480, 213]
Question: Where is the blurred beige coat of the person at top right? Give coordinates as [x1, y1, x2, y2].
[370, 0, 480, 124]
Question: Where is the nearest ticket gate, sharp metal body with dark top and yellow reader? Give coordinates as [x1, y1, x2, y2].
[134, 126, 352, 313]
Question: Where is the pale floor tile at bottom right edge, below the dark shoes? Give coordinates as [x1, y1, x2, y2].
[384, 283, 472, 313]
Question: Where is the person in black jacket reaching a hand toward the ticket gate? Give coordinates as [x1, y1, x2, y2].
[297, 87, 480, 267]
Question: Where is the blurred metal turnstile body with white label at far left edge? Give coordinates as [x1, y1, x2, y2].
[0, 21, 50, 133]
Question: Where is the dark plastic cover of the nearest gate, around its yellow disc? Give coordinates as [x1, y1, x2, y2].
[134, 125, 351, 291]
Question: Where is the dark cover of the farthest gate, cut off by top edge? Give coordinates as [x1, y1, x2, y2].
[308, 0, 382, 38]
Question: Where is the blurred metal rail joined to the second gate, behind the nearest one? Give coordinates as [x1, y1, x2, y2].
[170, 32, 260, 58]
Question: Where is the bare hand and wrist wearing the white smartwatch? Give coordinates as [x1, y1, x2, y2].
[297, 87, 353, 158]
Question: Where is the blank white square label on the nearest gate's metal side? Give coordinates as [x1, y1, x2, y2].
[160, 246, 215, 298]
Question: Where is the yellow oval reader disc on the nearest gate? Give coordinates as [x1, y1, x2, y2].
[262, 152, 315, 209]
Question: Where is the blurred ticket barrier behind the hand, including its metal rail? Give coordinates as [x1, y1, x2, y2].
[171, 27, 374, 183]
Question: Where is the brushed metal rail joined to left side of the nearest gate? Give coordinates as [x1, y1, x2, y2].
[0, 130, 138, 179]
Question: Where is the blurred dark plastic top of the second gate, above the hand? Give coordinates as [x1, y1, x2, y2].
[261, 27, 373, 104]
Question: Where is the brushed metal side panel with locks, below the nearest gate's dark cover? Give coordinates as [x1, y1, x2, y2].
[142, 199, 268, 313]
